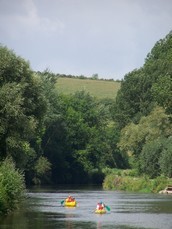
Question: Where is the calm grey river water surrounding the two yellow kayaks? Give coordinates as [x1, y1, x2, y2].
[0, 187, 172, 229]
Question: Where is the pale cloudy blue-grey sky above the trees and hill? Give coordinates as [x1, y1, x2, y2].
[0, 0, 172, 80]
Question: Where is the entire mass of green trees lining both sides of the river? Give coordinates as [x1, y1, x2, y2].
[0, 30, 172, 209]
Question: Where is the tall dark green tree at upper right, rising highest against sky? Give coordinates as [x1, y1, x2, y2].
[113, 32, 172, 128]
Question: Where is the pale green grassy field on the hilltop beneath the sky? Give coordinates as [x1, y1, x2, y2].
[57, 78, 121, 99]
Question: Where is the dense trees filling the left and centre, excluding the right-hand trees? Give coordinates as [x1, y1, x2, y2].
[0, 46, 124, 188]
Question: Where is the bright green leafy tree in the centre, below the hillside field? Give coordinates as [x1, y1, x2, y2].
[63, 91, 125, 182]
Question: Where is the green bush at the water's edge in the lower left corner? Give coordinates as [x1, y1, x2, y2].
[0, 158, 25, 214]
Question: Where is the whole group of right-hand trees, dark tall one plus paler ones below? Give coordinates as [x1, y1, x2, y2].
[113, 32, 172, 178]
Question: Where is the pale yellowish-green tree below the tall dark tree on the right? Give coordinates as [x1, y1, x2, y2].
[118, 107, 172, 154]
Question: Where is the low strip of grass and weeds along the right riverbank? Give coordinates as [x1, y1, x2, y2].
[103, 170, 172, 193]
